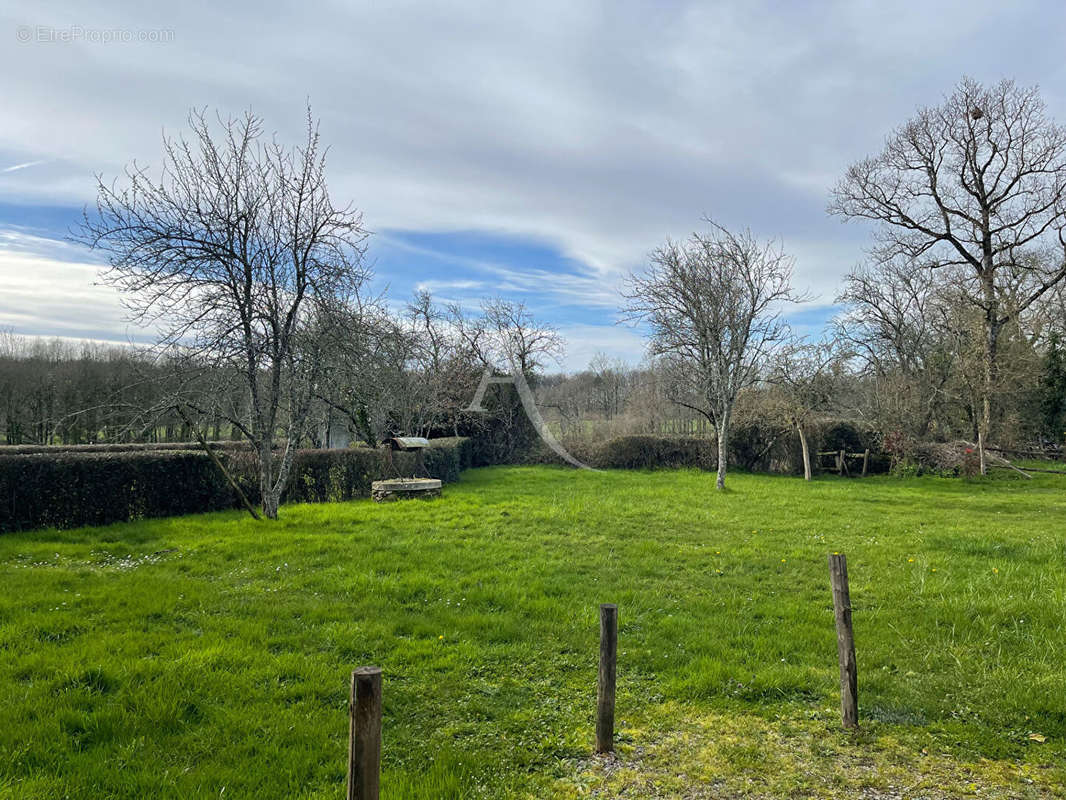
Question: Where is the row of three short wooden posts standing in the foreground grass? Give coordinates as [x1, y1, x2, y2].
[348, 553, 859, 800]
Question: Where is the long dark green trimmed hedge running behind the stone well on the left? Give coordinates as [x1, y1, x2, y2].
[0, 437, 473, 531]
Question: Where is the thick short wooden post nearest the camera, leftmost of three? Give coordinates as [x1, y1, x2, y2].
[348, 667, 382, 800]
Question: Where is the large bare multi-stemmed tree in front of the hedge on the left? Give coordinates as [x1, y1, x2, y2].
[76, 110, 368, 518]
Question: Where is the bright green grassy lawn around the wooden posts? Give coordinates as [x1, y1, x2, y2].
[0, 467, 1066, 800]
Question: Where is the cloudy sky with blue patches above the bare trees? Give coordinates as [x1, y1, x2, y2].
[0, 0, 1066, 369]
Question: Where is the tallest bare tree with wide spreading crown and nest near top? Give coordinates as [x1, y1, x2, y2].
[829, 78, 1066, 467]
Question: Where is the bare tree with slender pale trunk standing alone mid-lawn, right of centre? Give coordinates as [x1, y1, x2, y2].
[624, 220, 801, 489]
